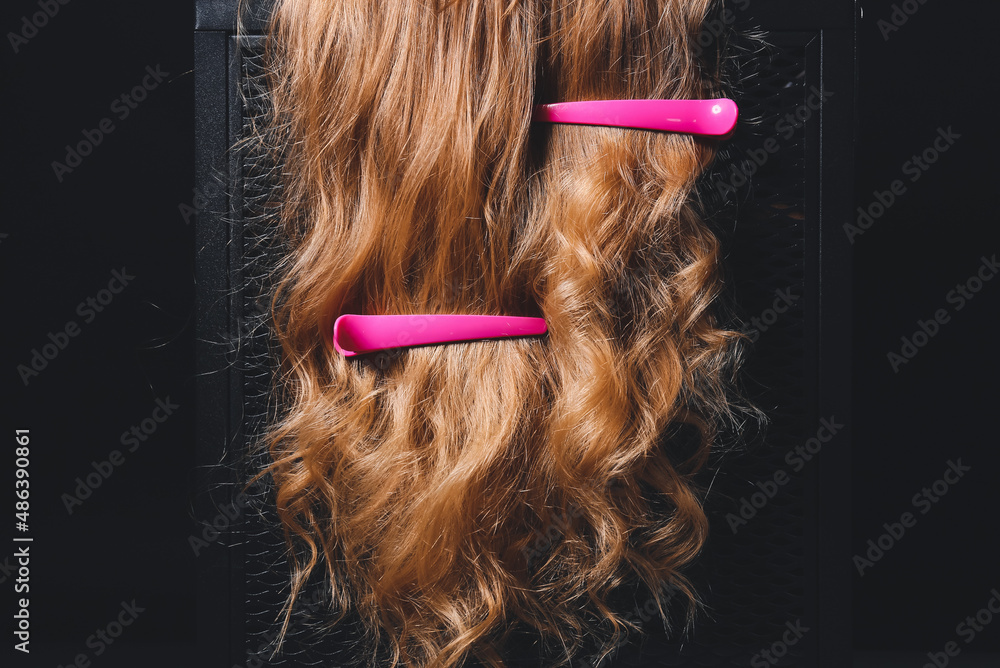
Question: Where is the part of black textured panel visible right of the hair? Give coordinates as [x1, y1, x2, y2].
[684, 38, 817, 666]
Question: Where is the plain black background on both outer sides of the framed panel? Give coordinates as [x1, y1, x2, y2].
[0, 0, 1000, 666]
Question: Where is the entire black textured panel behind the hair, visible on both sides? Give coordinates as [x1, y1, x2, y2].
[231, 36, 820, 668]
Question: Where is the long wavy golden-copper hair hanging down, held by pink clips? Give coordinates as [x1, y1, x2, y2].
[265, 0, 752, 668]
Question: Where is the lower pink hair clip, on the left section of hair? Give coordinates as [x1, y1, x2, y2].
[333, 314, 548, 357]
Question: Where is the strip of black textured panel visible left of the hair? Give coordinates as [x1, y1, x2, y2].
[235, 38, 372, 667]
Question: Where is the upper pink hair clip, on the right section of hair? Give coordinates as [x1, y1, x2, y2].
[531, 97, 739, 136]
